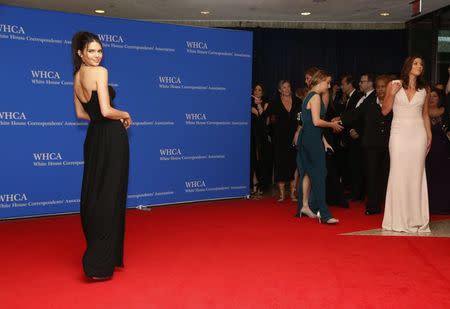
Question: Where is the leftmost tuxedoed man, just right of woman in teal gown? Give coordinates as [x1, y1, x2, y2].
[337, 75, 363, 200]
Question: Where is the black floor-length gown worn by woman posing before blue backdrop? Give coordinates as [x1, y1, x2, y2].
[80, 87, 129, 277]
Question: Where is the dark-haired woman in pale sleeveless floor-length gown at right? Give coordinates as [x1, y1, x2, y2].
[382, 57, 431, 233]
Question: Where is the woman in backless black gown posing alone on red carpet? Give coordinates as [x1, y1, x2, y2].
[72, 32, 131, 280]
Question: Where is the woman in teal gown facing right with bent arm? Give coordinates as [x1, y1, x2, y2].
[297, 70, 343, 224]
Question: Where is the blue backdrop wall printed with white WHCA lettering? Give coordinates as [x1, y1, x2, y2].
[0, 6, 252, 218]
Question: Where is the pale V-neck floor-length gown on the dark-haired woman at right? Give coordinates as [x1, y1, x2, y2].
[382, 87, 430, 233]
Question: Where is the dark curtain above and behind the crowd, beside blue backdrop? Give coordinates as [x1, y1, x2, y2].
[242, 28, 408, 97]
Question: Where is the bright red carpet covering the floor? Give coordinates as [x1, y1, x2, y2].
[0, 199, 450, 309]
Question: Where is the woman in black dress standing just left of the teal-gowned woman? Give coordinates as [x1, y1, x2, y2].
[268, 80, 301, 202]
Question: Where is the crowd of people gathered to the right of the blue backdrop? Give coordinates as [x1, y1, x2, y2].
[250, 57, 450, 224]
